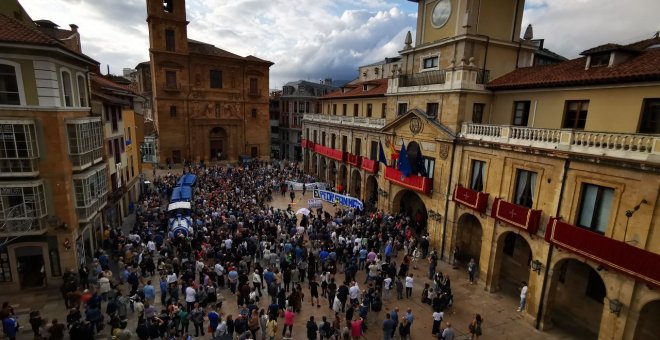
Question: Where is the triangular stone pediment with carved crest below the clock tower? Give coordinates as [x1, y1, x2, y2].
[381, 109, 456, 141]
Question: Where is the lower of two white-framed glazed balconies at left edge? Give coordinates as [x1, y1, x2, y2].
[0, 181, 48, 232]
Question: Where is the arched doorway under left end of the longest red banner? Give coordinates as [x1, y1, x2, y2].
[545, 258, 604, 339]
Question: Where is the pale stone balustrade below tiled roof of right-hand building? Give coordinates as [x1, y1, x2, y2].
[460, 123, 660, 163]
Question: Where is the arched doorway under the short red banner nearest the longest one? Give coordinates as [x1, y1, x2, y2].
[493, 231, 532, 297]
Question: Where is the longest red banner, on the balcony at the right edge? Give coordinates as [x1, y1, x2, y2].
[545, 218, 660, 287]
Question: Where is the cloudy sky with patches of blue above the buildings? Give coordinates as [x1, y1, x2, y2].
[19, 0, 660, 88]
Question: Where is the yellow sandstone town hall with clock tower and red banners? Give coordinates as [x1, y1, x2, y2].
[303, 0, 660, 339]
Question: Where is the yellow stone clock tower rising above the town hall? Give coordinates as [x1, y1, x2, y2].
[388, 0, 534, 133]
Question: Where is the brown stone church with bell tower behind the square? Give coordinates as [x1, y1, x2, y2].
[147, 0, 273, 163]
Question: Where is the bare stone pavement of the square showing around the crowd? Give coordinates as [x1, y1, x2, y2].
[0, 166, 579, 340]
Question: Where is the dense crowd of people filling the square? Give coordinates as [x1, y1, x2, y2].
[3, 162, 464, 340]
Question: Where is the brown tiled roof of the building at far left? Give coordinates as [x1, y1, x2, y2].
[0, 14, 98, 64]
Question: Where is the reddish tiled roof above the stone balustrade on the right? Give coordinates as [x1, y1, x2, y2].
[487, 38, 660, 90]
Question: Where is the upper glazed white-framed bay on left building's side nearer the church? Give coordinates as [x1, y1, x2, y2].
[67, 118, 103, 167]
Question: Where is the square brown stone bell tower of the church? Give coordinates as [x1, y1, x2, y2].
[147, 0, 188, 54]
